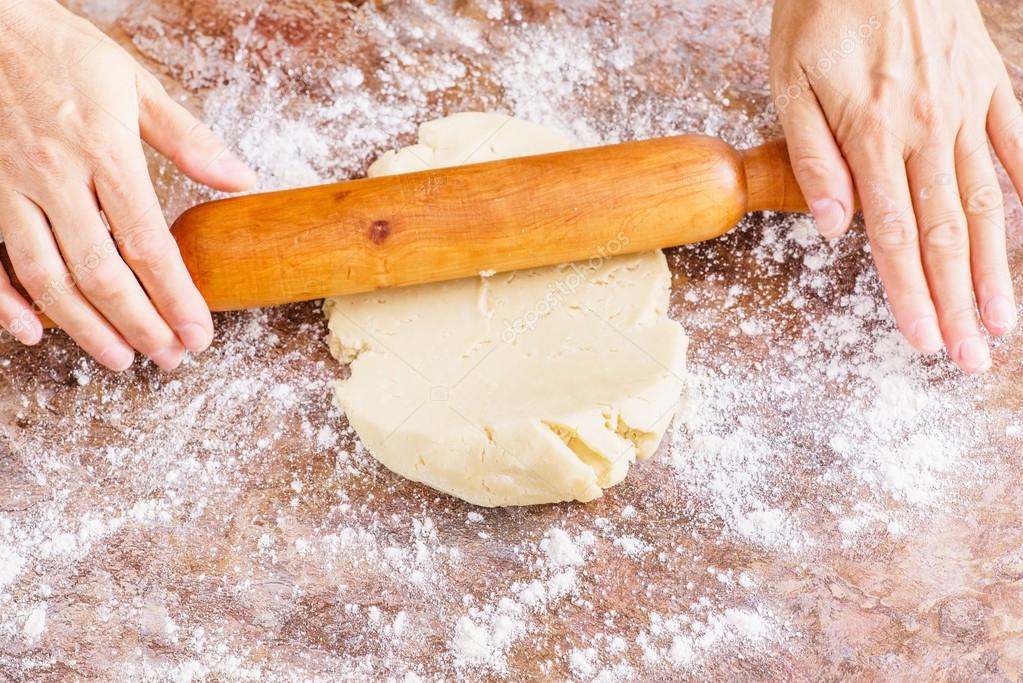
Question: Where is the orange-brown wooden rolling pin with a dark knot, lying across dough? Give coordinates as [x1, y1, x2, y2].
[6, 135, 806, 311]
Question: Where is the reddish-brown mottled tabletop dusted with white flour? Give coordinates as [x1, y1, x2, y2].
[0, 0, 1023, 681]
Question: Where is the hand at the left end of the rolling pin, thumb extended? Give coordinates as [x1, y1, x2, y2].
[0, 0, 256, 370]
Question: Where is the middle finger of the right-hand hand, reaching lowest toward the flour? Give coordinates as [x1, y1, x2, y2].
[906, 143, 991, 372]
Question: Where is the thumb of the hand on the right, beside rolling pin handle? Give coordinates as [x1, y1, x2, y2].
[780, 91, 853, 239]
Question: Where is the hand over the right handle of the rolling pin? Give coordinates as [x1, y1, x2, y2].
[770, 0, 1023, 372]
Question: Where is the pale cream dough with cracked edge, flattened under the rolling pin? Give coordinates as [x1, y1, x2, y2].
[324, 113, 686, 506]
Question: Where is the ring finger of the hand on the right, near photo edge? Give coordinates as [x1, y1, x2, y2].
[955, 130, 1018, 336]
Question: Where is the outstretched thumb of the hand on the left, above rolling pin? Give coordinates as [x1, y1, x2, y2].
[138, 74, 257, 192]
